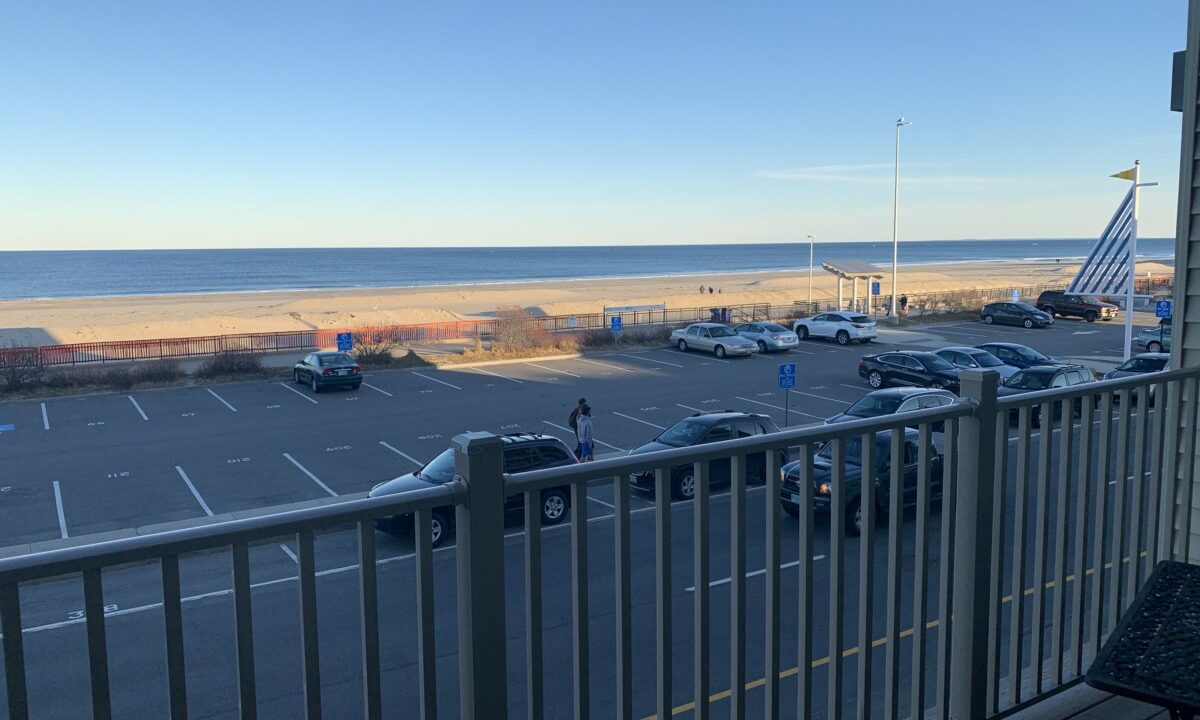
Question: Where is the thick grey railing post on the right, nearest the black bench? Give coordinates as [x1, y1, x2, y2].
[942, 370, 1000, 720]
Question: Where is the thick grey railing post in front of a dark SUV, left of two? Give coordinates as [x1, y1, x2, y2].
[452, 432, 509, 720]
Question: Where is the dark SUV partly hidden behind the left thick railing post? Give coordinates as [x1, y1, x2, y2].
[367, 433, 577, 546]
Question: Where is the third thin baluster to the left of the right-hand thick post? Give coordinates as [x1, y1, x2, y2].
[883, 422, 902, 720]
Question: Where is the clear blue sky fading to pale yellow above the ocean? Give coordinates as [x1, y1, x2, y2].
[0, 0, 1187, 250]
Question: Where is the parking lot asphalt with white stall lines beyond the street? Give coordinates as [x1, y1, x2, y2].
[0, 318, 1153, 716]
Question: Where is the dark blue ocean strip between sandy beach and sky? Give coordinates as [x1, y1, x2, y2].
[0, 239, 1175, 300]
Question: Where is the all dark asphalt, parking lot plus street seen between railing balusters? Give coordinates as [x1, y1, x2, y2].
[0, 319, 1152, 718]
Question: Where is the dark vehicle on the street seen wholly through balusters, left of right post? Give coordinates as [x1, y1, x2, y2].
[779, 428, 942, 535]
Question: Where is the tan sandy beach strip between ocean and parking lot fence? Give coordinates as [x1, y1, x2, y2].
[0, 256, 1174, 346]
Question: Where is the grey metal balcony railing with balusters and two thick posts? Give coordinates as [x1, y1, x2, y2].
[0, 370, 1200, 720]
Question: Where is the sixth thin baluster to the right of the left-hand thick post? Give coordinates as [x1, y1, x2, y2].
[730, 455, 744, 719]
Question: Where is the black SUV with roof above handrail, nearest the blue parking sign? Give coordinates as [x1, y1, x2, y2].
[629, 410, 787, 500]
